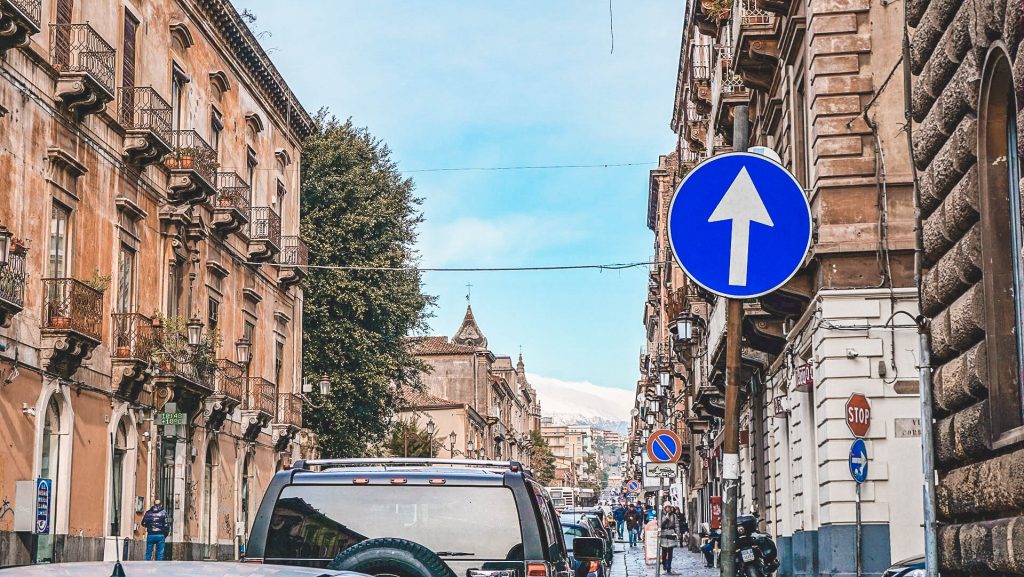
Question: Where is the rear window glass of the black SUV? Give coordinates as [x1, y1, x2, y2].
[264, 485, 523, 567]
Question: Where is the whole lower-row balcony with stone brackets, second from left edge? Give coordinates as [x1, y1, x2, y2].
[42, 278, 103, 378]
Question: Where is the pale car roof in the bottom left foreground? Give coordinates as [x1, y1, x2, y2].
[0, 561, 370, 577]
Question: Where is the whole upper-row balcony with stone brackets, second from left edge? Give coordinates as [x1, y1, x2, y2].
[50, 24, 115, 118]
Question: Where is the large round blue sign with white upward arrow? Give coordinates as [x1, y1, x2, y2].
[669, 153, 811, 298]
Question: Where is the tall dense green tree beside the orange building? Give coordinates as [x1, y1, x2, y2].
[302, 110, 432, 457]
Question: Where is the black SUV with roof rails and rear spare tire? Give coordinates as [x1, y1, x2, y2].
[246, 459, 603, 577]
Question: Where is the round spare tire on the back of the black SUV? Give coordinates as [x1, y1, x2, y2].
[328, 537, 456, 577]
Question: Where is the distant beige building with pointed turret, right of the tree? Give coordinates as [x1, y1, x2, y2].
[407, 306, 541, 466]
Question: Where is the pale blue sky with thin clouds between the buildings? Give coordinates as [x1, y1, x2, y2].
[236, 0, 684, 395]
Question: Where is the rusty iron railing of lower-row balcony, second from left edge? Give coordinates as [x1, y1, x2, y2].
[43, 279, 103, 341]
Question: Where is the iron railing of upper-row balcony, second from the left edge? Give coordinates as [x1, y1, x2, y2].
[50, 24, 116, 94]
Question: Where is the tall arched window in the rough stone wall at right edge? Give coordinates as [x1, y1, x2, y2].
[978, 42, 1024, 440]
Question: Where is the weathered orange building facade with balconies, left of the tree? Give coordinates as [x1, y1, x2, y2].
[0, 0, 314, 565]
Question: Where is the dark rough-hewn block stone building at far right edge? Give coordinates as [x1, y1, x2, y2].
[906, 0, 1024, 575]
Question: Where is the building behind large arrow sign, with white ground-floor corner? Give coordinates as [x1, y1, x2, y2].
[631, 0, 929, 575]
